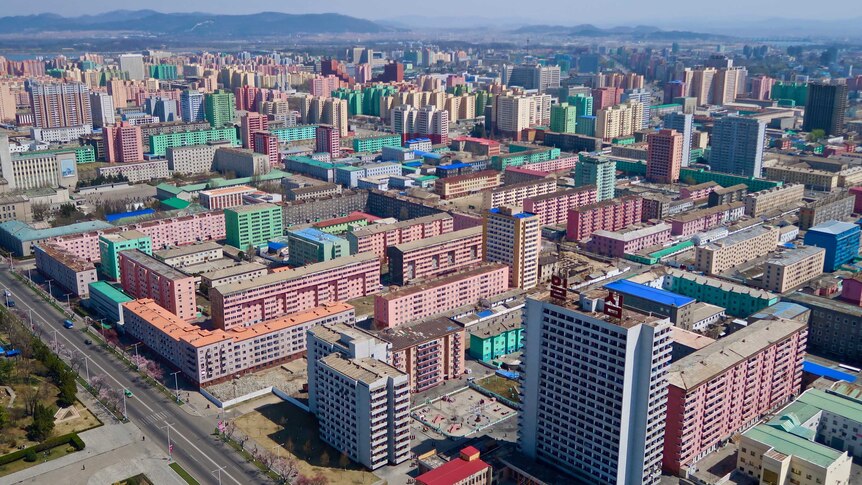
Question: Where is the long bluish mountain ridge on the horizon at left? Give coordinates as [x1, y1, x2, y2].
[0, 10, 397, 38]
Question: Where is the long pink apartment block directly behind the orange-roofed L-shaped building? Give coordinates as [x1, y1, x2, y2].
[209, 253, 380, 330]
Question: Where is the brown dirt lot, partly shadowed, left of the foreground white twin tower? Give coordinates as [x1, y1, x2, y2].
[236, 402, 380, 485]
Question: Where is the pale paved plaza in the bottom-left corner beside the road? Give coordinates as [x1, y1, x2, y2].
[5, 423, 185, 485]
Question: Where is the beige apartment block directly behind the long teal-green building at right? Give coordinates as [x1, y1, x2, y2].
[695, 226, 779, 275]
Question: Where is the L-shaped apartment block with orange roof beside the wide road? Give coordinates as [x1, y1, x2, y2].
[122, 299, 356, 386]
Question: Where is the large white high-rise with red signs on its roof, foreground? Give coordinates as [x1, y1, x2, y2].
[518, 290, 676, 485]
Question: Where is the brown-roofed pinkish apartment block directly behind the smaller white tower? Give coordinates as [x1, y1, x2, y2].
[377, 318, 466, 392]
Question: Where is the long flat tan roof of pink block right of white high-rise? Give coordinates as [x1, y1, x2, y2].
[668, 319, 808, 390]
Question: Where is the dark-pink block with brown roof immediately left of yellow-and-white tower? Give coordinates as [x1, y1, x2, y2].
[386, 227, 483, 286]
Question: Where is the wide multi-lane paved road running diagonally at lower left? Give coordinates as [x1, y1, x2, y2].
[0, 268, 270, 485]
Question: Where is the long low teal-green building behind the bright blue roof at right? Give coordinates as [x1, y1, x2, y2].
[664, 269, 780, 318]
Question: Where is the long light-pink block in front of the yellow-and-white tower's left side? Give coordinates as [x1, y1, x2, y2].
[374, 263, 509, 328]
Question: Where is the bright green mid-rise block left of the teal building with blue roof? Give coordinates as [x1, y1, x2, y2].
[224, 204, 284, 251]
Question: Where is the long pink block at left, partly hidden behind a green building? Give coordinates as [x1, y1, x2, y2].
[48, 211, 227, 263]
